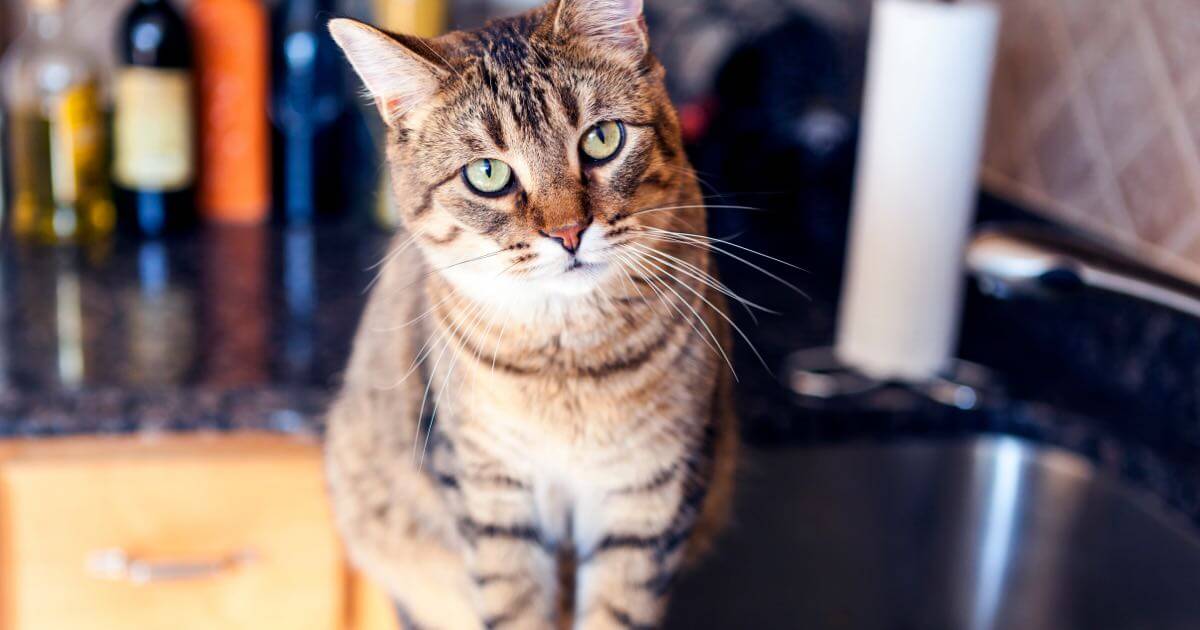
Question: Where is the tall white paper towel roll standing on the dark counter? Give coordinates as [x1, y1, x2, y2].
[835, 0, 1000, 380]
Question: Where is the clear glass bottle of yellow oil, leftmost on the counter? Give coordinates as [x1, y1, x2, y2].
[0, 0, 115, 245]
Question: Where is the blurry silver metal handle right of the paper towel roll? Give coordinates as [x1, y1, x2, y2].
[966, 228, 1200, 318]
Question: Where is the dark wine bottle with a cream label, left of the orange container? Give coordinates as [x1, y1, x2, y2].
[113, 0, 197, 238]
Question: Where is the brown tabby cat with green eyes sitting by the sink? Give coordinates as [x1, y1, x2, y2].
[325, 0, 738, 630]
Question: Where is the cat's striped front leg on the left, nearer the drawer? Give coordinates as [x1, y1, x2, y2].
[457, 458, 557, 630]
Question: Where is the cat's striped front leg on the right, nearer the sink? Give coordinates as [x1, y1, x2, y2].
[575, 460, 704, 630]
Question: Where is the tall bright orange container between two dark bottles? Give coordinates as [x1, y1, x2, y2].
[191, 0, 271, 223]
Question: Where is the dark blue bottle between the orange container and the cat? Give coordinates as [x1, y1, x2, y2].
[271, 0, 350, 223]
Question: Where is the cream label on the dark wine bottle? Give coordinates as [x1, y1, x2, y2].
[113, 67, 196, 192]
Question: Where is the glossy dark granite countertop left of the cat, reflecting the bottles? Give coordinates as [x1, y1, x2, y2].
[0, 224, 388, 436]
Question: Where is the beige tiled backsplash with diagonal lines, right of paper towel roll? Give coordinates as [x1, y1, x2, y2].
[984, 0, 1200, 270]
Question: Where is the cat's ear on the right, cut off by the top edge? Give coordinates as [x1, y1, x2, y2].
[551, 0, 649, 58]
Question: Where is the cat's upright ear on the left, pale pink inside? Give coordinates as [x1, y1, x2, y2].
[329, 18, 449, 125]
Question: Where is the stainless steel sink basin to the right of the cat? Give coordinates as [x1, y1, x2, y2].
[667, 437, 1200, 630]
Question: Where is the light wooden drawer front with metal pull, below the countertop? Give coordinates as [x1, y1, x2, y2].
[0, 437, 346, 630]
